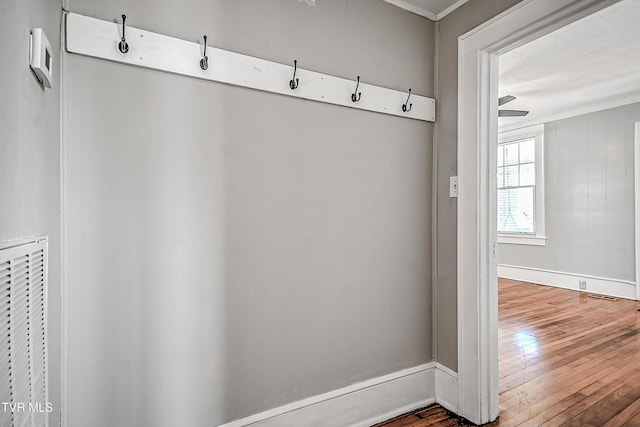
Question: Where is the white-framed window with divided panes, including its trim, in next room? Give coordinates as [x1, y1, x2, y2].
[497, 125, 545, 245]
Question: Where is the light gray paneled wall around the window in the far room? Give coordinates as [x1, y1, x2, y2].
[497, 104, 640, 281]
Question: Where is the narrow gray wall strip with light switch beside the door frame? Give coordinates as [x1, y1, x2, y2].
[434, 0, 519, 370]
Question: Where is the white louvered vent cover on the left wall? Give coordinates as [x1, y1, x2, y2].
[0, 239, 51, 427]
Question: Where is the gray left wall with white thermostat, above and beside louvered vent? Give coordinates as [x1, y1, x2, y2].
[0, 0, 60, 425]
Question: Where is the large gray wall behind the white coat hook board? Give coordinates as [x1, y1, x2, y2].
[65, 0, 434, 426]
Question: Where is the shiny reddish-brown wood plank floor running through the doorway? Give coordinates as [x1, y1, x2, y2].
[378, 279, 640, 427]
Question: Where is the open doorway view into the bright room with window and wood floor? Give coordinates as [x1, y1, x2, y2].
[496, 0, 640, 424]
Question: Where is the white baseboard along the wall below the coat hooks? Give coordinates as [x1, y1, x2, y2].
[219, 362, 436, 427]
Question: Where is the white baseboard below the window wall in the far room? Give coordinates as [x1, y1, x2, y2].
[498, 264, 636, 300]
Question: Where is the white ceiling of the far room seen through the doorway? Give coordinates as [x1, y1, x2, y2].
[498, 0, 640, 131]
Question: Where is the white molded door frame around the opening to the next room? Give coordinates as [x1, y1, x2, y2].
[457, 0, 624, 424]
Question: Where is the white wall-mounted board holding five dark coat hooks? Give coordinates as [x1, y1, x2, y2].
[66, 13, 435, 122]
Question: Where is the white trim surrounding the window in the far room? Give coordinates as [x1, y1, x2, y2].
[498, 124, 547, 246]
